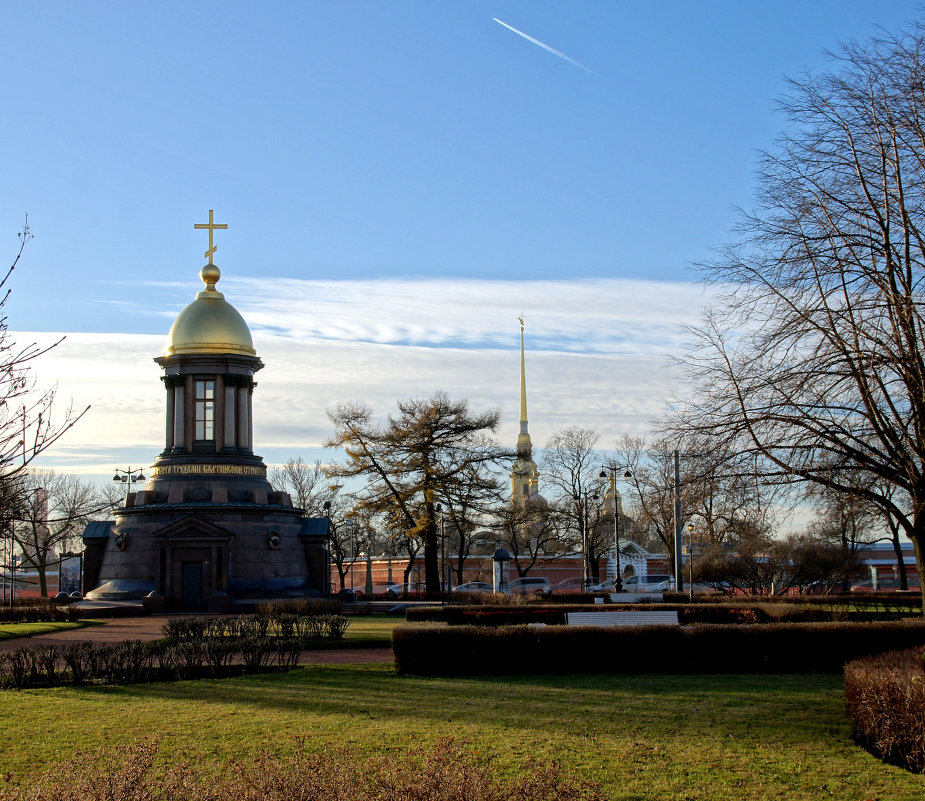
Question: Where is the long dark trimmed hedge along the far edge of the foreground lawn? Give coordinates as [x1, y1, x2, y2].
[392, 621, 925, 676]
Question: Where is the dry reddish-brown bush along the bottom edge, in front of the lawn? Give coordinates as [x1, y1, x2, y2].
[0, 738, 605, 801]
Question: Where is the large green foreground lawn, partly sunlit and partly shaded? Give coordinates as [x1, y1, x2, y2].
[0, 665, 925, 801]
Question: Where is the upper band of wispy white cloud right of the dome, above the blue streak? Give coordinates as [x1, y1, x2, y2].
[224, 279, 707, 354]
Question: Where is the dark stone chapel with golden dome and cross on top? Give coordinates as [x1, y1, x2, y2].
[83, 210, 330, 612]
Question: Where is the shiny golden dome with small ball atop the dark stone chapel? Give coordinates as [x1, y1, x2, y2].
[164, 264, 257, 356]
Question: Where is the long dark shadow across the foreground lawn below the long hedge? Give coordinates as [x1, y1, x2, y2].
[72, 665, 846, 745]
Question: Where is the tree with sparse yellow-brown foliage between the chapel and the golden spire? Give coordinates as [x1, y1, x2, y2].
[325, 392, 513, 593]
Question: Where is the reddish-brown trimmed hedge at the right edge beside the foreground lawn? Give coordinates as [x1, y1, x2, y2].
[845, 647, 925, 773]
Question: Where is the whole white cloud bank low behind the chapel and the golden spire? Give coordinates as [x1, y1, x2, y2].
[21, 279, 704, 473]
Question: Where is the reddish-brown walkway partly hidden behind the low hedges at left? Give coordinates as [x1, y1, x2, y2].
[0, 616, 392, 665]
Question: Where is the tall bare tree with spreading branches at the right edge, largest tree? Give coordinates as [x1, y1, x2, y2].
[664, 24, 925, 608]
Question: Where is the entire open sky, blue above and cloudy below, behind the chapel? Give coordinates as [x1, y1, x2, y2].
[0, 0, 919, 476]
